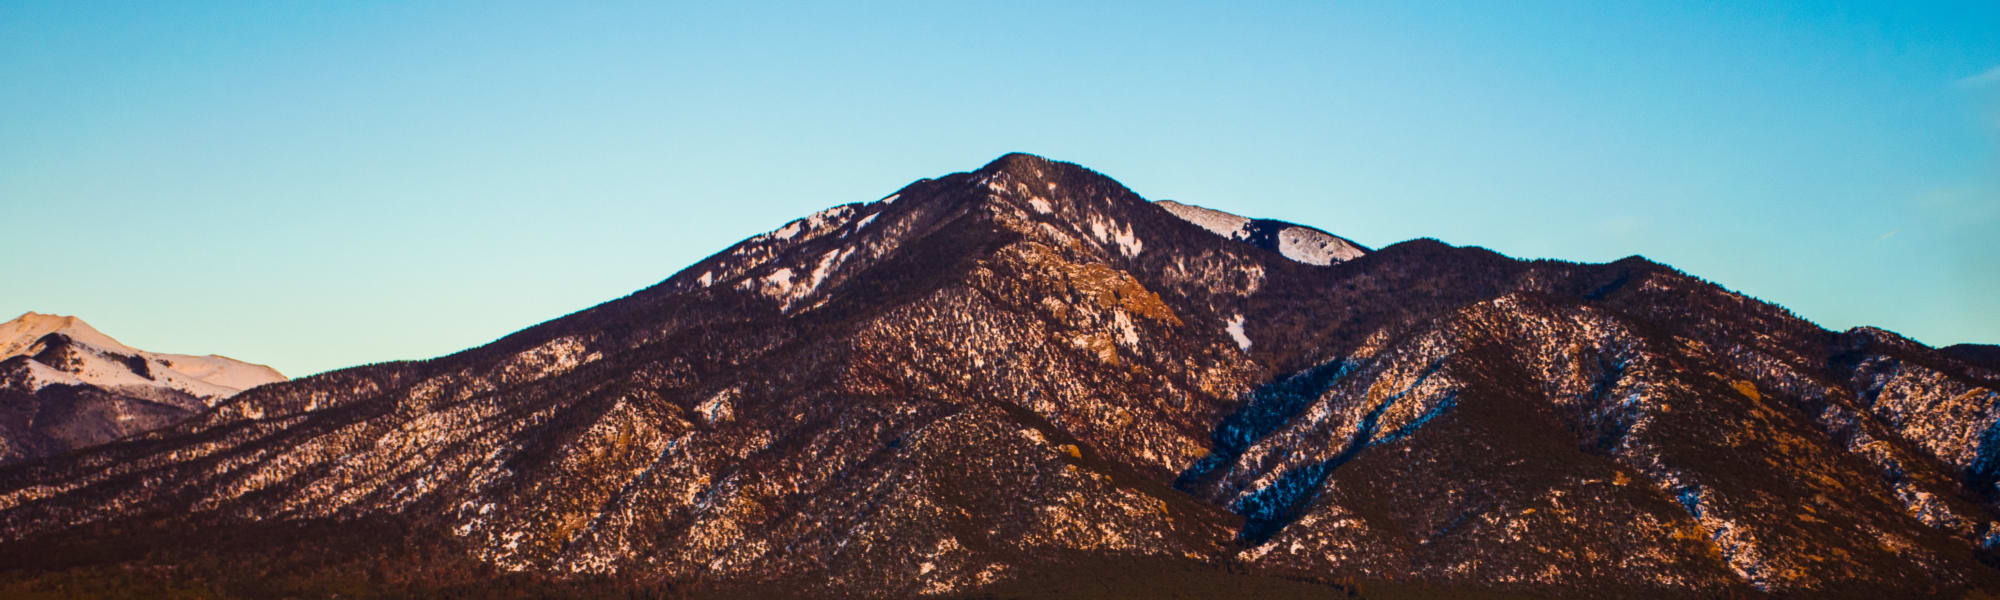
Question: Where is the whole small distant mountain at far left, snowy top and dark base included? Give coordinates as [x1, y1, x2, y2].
[0, 312, 284, 462]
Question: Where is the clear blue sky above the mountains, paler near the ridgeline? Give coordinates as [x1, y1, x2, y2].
[0, 0, 2000, 376]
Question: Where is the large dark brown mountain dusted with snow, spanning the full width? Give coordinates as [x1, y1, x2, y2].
[0, 154, 2000, 598]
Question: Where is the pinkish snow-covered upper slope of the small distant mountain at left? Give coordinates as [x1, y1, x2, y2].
[0, 312, 286, 406]
